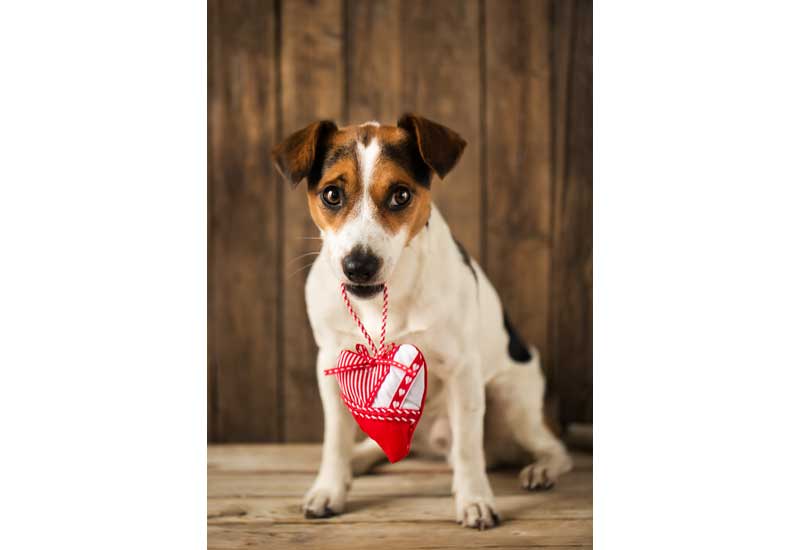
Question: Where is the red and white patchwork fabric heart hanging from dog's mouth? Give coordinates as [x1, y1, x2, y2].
[325, 344, 428, 462]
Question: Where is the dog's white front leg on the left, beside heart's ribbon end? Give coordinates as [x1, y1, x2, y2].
[303, 349, 356, 518]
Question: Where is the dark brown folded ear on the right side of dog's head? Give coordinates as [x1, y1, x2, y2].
[397, 113, 467, 179]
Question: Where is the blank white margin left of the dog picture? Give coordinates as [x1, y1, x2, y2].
[0, 1, 206, 549]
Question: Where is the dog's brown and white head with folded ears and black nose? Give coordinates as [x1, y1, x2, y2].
[272, 114, 466, 298]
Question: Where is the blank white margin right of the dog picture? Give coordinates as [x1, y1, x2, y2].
[594, 2, 800, 549]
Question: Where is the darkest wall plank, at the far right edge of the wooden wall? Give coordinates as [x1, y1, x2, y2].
[550, 0, 592, 423]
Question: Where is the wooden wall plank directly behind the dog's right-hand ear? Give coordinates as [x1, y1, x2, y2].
[401, 0, 482, 258]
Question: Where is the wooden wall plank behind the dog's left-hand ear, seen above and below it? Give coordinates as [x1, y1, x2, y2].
[280, 0, 344, 441]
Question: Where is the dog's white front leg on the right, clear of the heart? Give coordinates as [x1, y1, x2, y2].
[447, 355, 499, 529]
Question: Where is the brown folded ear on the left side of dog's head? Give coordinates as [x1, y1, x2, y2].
[272, 120, 337, 186]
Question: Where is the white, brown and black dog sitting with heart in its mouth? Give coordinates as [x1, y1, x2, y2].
[272, 114, 572, 529]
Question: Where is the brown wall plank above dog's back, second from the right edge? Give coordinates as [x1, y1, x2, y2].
[484, 0, 552, 369]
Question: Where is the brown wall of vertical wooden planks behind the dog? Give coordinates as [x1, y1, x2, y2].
[207, 0, 592, 442]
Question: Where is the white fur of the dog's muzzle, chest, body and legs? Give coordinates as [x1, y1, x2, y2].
[305, 202, 571, 527]
